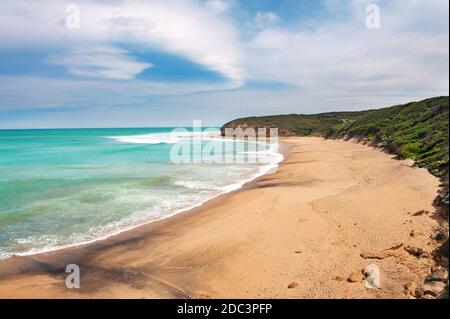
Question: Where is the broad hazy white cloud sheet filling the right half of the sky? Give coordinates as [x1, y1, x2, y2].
[245, 0, 449, 100]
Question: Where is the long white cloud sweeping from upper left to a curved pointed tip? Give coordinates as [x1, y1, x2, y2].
[0, 0, 243, 87]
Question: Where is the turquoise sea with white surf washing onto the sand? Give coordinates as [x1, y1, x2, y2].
[0, 128, 282, 259]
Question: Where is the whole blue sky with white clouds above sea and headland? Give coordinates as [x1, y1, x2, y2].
[0, 0, 449, 129]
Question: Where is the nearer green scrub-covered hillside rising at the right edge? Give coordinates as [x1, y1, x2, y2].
[330, 97, 449, 177]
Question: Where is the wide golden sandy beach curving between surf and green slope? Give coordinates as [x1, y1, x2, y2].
[0, 137, 439, 298]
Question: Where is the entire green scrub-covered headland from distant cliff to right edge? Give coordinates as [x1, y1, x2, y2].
[223, 96, 449, 212]
